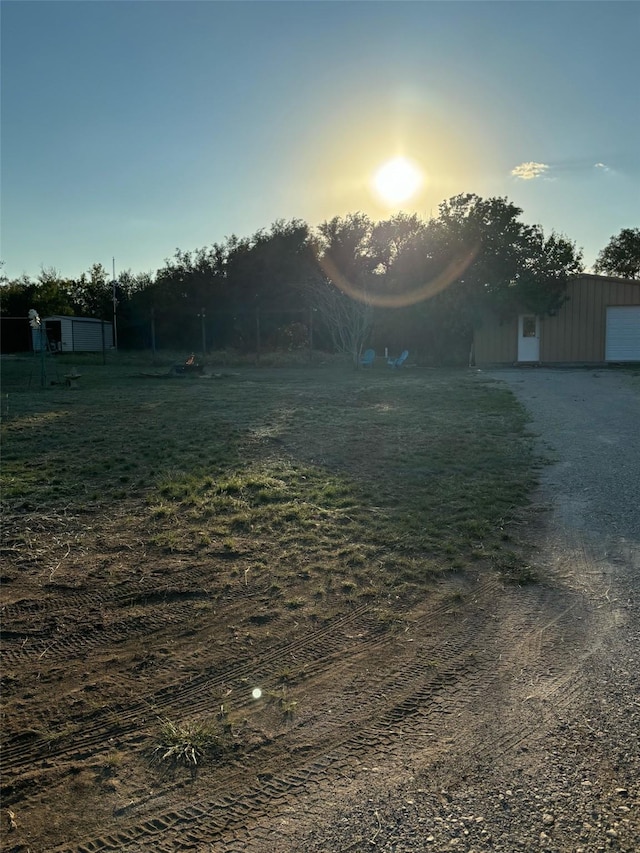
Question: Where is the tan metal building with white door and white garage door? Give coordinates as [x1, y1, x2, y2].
[474, 274, 640, 365]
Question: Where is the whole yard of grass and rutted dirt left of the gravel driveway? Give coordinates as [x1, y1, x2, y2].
[0, 357, 536, 850]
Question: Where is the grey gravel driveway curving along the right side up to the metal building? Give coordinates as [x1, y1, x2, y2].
[288, 369, 640, 853]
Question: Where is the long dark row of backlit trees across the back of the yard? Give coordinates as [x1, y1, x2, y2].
[0, 194, 640, 364]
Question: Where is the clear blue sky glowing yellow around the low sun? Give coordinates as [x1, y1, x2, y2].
[0, 0, 640, 279]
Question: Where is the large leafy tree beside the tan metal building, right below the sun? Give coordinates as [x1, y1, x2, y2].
[376, 194, 582, 363]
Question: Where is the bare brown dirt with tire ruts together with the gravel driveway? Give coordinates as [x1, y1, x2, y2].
[2, 371, 640, 853]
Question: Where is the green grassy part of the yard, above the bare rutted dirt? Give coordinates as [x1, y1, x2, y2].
[2, 357, 535, 592]
